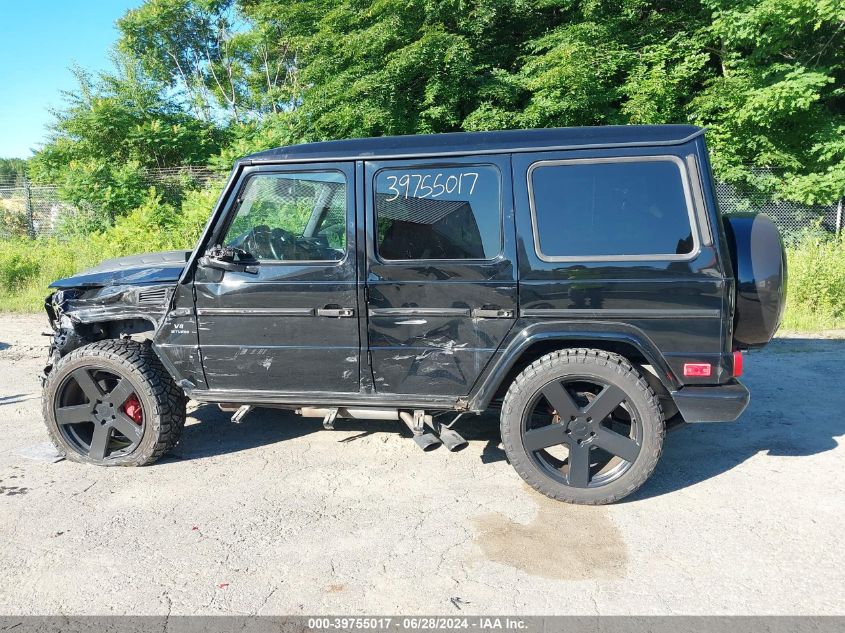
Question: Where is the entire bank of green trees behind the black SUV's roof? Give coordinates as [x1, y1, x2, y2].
[34, 0, 845, 208]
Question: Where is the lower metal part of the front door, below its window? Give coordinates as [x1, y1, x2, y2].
[197, 273, 358, 391]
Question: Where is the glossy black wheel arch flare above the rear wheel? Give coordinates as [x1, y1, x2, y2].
[468, 322, 680, 411]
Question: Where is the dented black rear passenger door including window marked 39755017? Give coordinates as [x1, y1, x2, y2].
[365, 156, 517, 396]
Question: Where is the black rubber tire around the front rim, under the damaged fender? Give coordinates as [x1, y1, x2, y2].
[42, 339, 186, 466]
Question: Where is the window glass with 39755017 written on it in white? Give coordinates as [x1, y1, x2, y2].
[375, 165, 502, 259]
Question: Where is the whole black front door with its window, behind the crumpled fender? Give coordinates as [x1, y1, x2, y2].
[194, 163, 360, 392]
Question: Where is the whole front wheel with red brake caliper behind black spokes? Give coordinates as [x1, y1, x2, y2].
[43, 339, 185, 466]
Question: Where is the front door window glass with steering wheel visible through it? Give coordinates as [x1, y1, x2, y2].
[225, 171, 346, 261]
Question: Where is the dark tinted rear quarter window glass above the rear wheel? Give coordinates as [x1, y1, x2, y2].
[531, 160, 693, 257]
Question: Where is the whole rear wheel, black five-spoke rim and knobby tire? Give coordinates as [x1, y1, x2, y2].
[501, 349, 664, 505]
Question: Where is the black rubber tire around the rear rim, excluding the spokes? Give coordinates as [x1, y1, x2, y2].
[501, 349, 665, 505]
